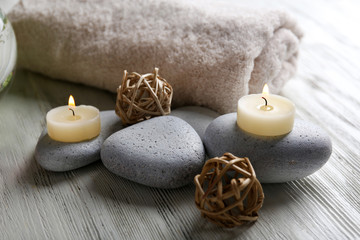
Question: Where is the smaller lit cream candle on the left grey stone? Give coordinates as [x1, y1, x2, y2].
[46, 95, 100, 142]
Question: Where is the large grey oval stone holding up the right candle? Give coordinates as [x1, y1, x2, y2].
[204, 113, 332, 183]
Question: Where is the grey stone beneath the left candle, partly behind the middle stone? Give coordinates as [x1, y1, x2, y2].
[35, 111, 123, 172]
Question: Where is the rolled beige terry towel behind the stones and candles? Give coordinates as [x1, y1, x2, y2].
[9, 0, 302, 113]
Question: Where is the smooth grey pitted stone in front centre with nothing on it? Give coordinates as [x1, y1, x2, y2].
[101, 116, 205, 188]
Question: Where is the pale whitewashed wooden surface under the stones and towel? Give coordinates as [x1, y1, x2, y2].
[0, 0, 360, 240]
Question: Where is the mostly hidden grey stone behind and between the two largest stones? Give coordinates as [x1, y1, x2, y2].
[170, 106, 220, 140]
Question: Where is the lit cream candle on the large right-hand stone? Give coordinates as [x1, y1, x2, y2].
[237, 84, 295, 136]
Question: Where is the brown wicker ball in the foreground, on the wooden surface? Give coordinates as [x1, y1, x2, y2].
[194, 153, 264, 227]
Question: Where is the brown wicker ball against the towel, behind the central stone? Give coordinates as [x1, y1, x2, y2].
[115, 68, 173, 125]
